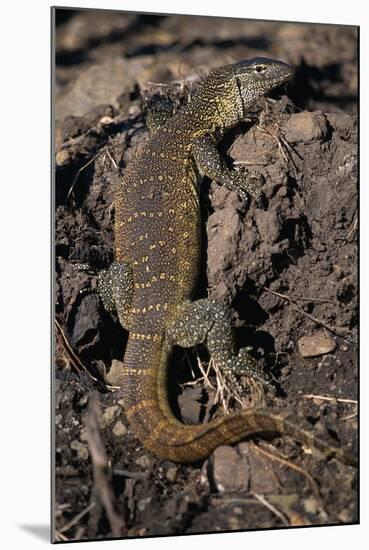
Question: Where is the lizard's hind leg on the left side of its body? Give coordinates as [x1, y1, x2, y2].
[98, 262, 133, 326]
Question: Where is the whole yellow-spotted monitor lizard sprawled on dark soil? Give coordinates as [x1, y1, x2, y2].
[99, 57, 354, 463]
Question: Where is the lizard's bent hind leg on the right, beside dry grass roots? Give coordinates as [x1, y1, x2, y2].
[166, 299, 274, 391]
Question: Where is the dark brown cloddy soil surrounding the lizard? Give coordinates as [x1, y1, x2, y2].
[55, 10, 358, 541]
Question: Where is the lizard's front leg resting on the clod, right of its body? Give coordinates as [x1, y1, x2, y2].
[192, 134, 263, 202]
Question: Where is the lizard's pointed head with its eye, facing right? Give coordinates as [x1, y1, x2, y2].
[229, 57, 294, 111]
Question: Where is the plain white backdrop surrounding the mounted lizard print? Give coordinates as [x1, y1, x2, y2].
[0, 0, 369, 550]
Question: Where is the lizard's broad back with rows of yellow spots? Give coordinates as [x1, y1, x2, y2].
[115, 114, 200, 332]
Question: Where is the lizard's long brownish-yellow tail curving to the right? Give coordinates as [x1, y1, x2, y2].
[121, 333, 356, 465]
